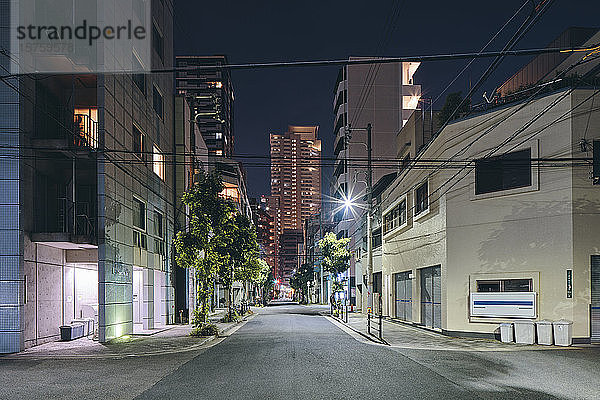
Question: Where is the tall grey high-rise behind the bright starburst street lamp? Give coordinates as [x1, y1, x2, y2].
[327, 57, 421, 304]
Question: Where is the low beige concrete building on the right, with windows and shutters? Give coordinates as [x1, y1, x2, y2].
[378, 87, 600, 342]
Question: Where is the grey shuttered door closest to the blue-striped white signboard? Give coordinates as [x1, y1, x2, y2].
[420, 265, 442, 328]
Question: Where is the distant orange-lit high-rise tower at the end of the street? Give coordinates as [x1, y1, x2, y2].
[270, 126, 321, 282]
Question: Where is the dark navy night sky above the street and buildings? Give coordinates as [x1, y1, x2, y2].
[175, 0, 600, 196]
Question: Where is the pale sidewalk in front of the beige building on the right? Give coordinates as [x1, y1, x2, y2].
[336, 313, 575, 351]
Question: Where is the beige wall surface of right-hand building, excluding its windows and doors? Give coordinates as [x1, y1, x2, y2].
[382, 91, 600, 338]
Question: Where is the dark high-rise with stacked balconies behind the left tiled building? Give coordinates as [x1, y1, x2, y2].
[175, 56, 234, 158]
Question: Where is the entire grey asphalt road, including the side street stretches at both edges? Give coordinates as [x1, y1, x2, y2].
[0, 305, 600, 400]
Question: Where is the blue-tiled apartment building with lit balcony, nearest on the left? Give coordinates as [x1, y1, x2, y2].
[0, 1, 175, 353]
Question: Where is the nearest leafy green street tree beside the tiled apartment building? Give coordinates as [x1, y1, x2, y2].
[173, 172, 228, 326]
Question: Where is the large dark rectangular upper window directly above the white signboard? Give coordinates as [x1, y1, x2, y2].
[475, 149, 531, 194]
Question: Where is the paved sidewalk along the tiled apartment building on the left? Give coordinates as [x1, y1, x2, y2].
[0, 309, 255, 359]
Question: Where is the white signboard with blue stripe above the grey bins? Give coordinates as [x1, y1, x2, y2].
[470, 292, 537, 318]
